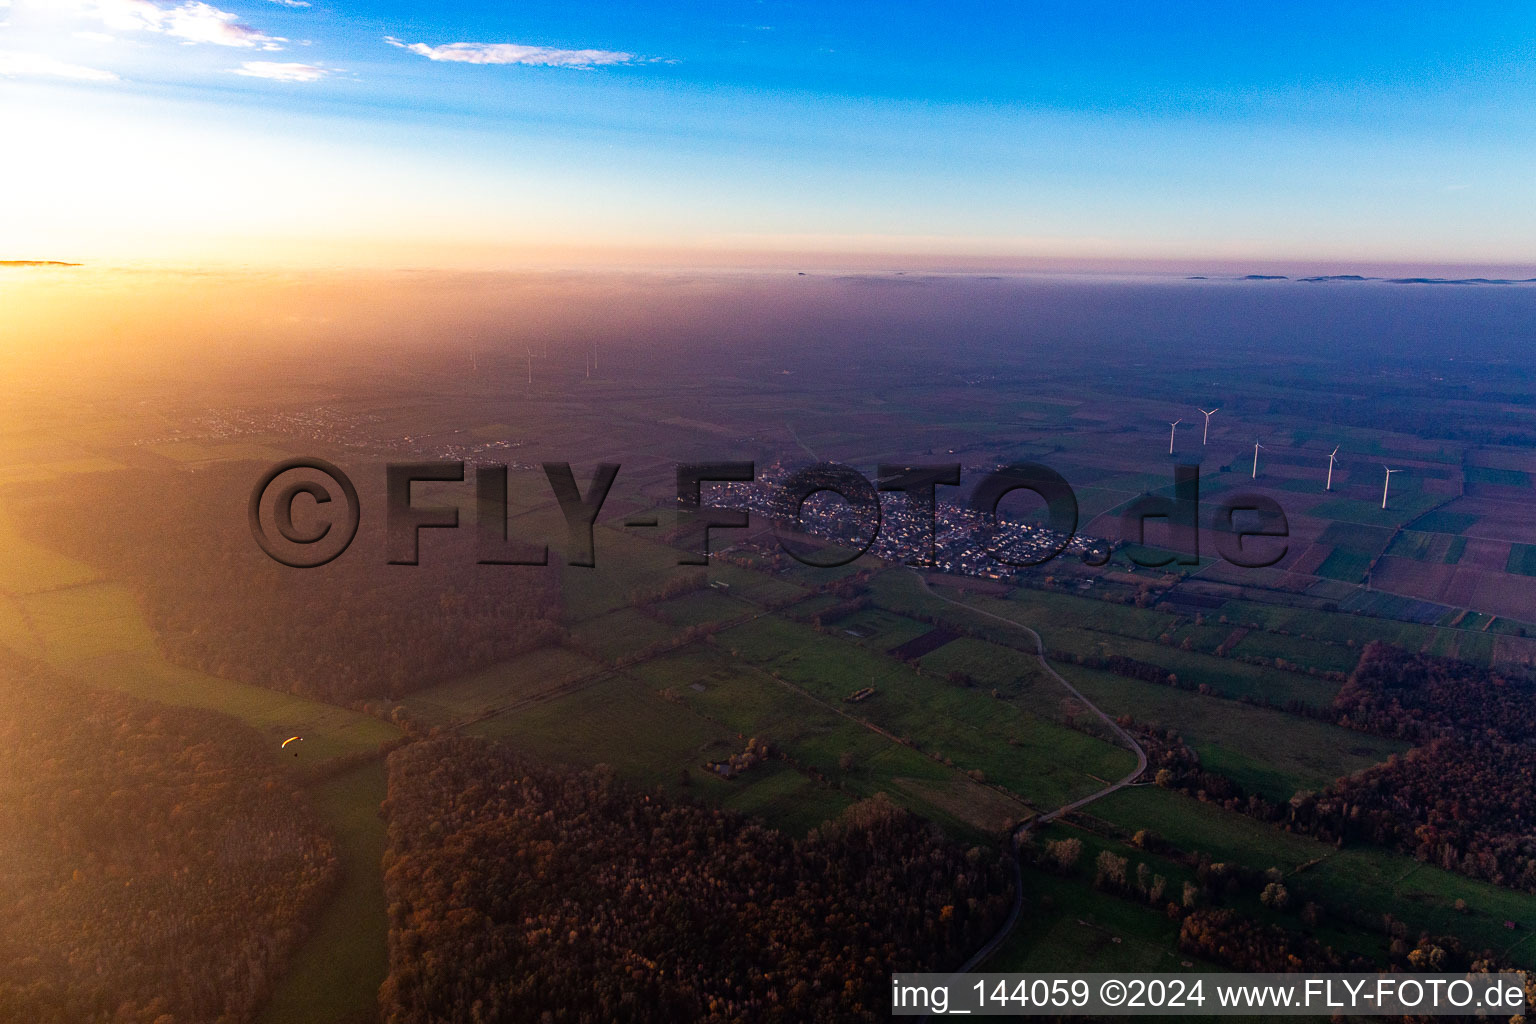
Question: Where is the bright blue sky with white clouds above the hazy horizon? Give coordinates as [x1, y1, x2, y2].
[0, 0, 1536, 266]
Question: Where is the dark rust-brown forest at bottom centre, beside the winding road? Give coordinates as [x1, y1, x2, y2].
[382, 738, 1011, 1024]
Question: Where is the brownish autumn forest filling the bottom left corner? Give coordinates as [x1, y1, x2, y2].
[0, 654, 338, 1024]
